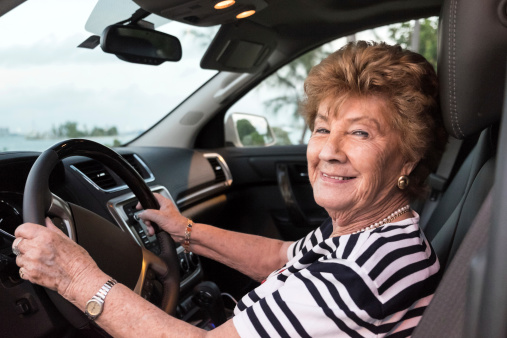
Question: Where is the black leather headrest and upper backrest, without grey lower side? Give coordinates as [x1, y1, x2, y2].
[416, 0, 507, 268]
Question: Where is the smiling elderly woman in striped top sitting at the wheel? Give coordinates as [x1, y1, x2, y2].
[13, 42, 445, 337]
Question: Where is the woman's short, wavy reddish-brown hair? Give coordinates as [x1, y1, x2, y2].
[302, 41, 447, 199]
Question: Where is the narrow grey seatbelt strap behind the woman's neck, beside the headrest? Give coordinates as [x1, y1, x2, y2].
[420, 136, 463, 229]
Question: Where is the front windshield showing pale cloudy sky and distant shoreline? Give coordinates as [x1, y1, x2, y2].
[0, 0, 218, 151]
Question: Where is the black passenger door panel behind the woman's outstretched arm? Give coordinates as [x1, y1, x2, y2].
[221, 145, 328, 240]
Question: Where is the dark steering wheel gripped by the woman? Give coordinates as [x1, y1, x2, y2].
[23, 139, 179, 328]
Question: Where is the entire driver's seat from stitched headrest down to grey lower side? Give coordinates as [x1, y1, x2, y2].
[413, 0, 507, 337]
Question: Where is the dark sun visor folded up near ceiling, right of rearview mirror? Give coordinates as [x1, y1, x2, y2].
[201, 21, 276, 73]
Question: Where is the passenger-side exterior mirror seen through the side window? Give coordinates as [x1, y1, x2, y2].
[225, 113, 276, 147]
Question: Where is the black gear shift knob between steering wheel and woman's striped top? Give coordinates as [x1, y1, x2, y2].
[193, 281, 226, 327]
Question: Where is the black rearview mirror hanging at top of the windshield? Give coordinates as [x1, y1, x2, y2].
[100, 24, 181, 65]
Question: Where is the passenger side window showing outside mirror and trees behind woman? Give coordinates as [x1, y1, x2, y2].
[224, 17, 438, 147]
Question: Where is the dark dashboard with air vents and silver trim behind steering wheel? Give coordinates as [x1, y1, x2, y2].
[0, 147, 232, 335]
